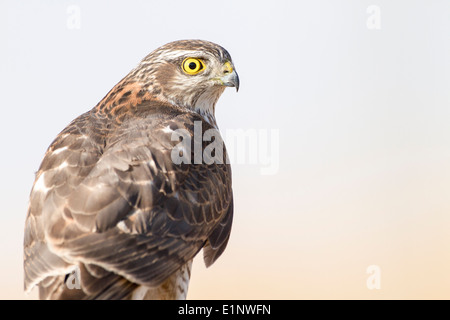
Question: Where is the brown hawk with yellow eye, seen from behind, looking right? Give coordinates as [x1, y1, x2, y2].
[24, 40, 239, 299]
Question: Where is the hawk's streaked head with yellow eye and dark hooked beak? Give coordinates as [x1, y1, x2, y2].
[132, 40, 239, 115]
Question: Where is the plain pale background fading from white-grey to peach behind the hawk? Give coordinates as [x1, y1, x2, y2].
[0, 0, 450, 299]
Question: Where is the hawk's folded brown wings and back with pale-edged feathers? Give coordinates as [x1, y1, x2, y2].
[25, 103, 232, 297]
